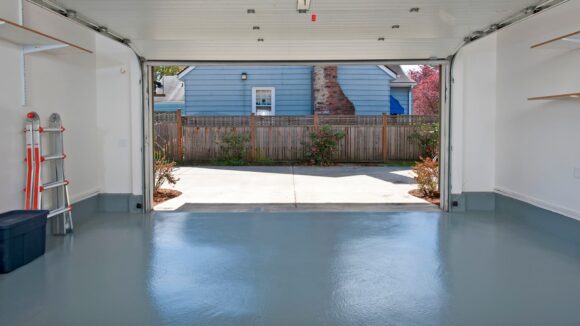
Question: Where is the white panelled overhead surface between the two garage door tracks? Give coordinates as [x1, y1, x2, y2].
[52, 0, 538, 60]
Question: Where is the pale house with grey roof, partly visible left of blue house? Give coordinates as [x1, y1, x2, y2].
[153, 76, 185, 112]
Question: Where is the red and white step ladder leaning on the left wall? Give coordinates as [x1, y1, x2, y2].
[24, 112, 73, 235]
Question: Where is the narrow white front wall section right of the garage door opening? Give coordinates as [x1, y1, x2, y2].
[451, 34, 497, 194]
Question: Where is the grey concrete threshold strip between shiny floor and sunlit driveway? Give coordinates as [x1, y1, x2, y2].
[173, 203, 440, 213]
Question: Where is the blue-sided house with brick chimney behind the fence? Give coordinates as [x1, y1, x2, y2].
[177, 65, 414, 115]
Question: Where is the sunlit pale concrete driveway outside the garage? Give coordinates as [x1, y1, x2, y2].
[155, 165, 428, 211]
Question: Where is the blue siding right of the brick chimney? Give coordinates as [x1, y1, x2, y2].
[338, 65, 393, 115]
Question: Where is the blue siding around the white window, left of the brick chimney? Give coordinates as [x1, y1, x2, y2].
[182, 66, 312, 115]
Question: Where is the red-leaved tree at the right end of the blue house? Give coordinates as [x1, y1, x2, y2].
[409, 65, 441, 115]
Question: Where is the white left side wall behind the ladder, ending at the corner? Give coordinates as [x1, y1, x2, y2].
[0, 1, 101, 211]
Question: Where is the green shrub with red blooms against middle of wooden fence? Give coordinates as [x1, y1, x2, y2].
[304, 125, 345, 165]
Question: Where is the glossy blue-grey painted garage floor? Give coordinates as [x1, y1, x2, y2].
[0, 212, 580, 325]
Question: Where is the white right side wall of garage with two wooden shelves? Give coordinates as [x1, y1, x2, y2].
[495, 1, 580, 218]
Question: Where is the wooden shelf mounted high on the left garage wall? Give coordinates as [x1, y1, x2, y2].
[0, 18, 93, 54]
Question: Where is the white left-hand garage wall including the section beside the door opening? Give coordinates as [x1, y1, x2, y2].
[0, 0, 142, 211]
